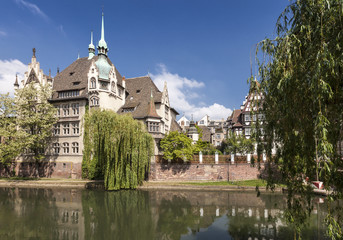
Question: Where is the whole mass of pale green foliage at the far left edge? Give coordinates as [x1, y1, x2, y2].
[0, 83, 57, 164]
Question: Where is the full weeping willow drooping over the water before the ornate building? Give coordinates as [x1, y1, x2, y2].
[82, 110, 153, 190]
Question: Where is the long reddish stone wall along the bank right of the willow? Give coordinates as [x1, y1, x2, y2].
[149, 163, 264, 181]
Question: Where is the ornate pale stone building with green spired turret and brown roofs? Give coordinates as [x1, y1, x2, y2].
[14, 15, 180, 178]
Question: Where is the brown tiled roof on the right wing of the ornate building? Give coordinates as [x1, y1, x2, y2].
[118, 76, 162, 118]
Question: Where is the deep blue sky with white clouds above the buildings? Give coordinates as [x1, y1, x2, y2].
[0, 0, 289, 120]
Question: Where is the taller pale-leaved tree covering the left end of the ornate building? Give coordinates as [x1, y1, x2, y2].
[14, 83, 57, 160]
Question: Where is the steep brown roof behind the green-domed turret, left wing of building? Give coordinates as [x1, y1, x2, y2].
[52, 56, 122, 99]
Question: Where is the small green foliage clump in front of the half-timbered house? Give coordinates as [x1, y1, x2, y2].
[224, 133, 255, 155]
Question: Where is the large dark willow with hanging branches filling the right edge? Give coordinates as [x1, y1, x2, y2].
[257, 0, 343, 238]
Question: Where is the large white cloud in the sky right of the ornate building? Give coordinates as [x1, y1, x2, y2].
[150, 64, 232, 120]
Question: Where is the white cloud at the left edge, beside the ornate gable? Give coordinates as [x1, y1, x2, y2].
[0, 59, 27, 96]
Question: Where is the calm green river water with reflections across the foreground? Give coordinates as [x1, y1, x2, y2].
[0, 188, 326, 240]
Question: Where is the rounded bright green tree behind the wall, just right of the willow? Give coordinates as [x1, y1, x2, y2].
[160, 131, 194, 161]
